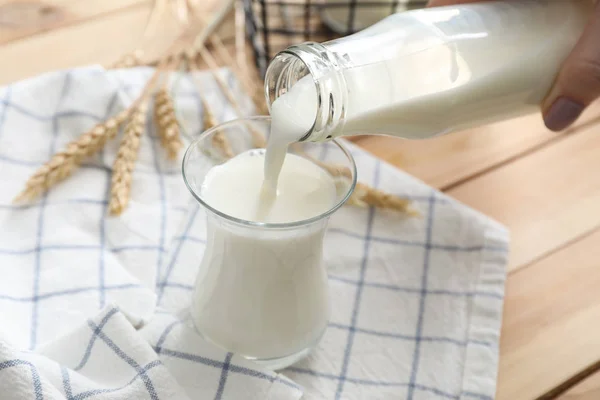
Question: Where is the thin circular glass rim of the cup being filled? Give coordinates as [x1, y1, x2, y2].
[181, 116, 357, 229]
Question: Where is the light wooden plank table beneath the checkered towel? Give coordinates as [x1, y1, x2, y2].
[0, 0, 600, 400]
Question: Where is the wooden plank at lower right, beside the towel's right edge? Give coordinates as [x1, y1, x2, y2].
[497, 228, 600, 400]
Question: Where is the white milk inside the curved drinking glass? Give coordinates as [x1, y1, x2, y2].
[192, 149, 336, 359]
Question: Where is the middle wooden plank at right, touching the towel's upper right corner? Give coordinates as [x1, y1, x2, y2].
[448, 116, 600, 270]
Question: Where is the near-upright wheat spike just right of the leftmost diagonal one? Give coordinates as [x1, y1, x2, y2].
[108, 103, 147, 215]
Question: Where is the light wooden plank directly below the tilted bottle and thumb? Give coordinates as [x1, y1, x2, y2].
[356, 104, 600, 189]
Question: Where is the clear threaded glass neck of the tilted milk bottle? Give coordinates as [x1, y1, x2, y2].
[265, 42, 348, 142]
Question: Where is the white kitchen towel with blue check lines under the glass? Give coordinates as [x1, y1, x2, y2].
[0, 67, 508, 400]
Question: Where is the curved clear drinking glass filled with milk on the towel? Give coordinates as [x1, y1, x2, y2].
[183, 117, 356, 369]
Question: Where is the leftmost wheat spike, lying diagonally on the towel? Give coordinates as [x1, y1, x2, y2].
[15, 110, 128, 202]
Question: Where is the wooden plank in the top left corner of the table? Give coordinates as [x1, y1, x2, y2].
[0, 0, 146, 44]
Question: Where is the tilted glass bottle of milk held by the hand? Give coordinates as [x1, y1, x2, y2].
[265, 0, 593, 141]
